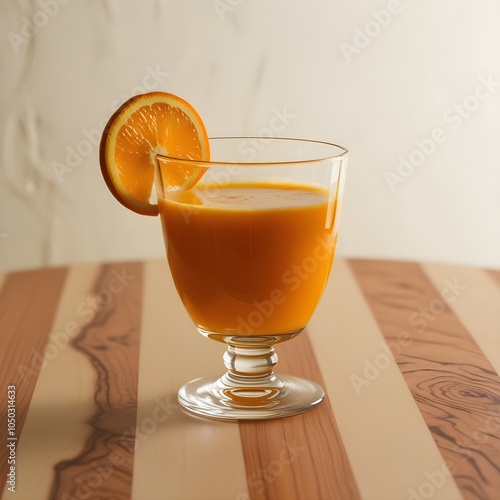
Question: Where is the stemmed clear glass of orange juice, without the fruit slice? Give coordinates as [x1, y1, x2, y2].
[155, 137, 347, 420]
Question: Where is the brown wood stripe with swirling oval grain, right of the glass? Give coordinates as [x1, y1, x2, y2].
[350, 260, 500, 499]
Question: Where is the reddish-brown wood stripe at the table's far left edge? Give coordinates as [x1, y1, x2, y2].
[0, 268, 67, 488]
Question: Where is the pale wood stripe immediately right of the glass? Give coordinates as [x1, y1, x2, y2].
[310, 259, 461, 500]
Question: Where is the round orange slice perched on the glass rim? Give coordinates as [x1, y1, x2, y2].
[99, 92, 209, 215]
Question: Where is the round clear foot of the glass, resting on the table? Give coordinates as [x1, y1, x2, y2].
[178, 374, 325, 420]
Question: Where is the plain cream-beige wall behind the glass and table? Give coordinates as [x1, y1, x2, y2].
[0, 0, 500, 270]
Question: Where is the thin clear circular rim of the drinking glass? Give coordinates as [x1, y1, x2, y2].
[154, 136, 349, 167]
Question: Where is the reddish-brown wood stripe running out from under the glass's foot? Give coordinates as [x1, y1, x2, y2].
[239, 332, 360, 500]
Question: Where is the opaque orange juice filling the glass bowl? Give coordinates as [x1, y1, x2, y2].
[159, 182, 335, 340]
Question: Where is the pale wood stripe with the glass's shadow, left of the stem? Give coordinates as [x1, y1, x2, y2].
[132, 260, 247, 500]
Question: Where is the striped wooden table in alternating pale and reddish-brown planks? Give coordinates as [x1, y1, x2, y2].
[0, 259, 500, 500]
